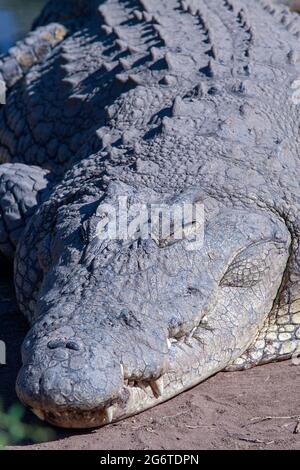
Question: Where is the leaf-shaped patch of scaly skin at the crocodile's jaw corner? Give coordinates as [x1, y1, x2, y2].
[220, 241, 284, 288]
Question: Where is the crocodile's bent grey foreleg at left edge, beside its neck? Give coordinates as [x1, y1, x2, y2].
[0, 163, 52, 259]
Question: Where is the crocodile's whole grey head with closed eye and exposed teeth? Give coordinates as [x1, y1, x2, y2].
[17, 183, 291, 428]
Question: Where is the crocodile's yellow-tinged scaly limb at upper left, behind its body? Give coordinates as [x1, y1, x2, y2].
[0, 23, 67, 90]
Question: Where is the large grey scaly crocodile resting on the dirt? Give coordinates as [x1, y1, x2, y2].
[0, 0, 300, 428]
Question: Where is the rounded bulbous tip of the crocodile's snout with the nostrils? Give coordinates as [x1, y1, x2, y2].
[17, 324, 126, 428]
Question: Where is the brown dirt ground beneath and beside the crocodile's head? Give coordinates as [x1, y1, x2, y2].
[0, 269, 300, 450]
